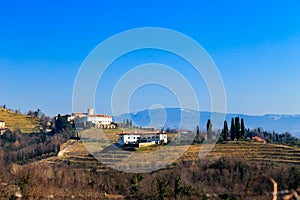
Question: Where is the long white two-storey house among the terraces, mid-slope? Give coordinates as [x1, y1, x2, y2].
[118, 132, 168, 147]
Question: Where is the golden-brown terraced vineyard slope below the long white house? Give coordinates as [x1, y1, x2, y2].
[48, 139, 300, 171]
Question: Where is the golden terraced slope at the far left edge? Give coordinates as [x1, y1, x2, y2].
[0, 108, 40, 133]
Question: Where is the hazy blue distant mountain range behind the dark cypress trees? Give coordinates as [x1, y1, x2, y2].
[114, 108, 300, 137]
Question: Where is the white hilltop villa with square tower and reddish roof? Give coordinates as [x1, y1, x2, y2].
[68, 108, 115, 128]
